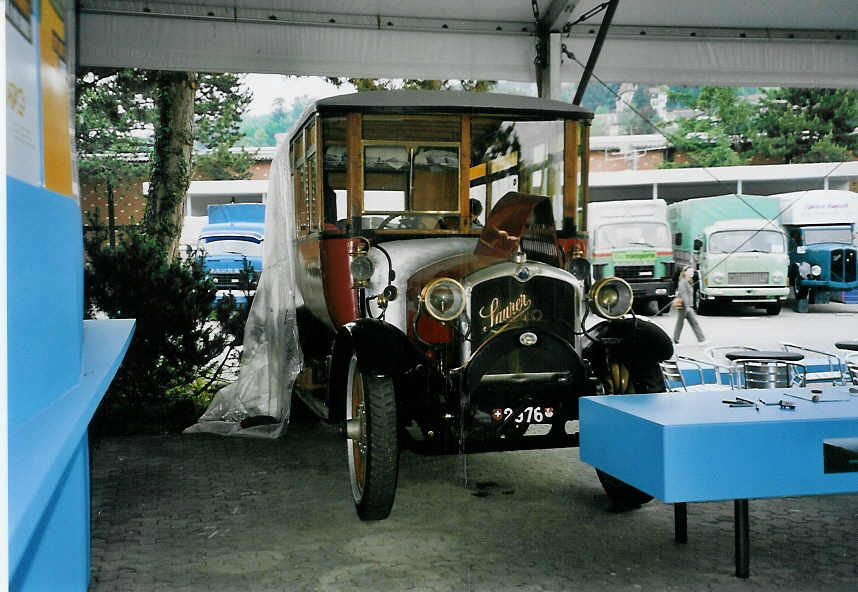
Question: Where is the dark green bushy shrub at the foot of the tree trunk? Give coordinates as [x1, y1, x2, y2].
[84, 229, 246, 435]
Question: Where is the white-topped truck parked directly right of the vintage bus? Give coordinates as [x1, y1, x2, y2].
[587, 199, 675, 313]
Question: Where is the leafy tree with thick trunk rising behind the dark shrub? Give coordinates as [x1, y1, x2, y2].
[76, 69, 252, 256]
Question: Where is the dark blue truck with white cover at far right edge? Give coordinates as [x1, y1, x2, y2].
[773, 189, 858, 312]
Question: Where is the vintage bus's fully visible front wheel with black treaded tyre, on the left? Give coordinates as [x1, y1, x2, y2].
[345, 355, 399, 520]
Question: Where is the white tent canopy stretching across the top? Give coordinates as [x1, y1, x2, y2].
[78, 0, 858, 87]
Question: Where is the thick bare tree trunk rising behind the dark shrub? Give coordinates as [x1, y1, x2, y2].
[143, 72, 197, 260]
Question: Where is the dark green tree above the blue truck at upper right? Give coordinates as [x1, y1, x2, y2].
[754, 88, 858, 163]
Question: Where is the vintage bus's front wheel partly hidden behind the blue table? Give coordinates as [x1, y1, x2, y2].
[596, 362, 664, 510]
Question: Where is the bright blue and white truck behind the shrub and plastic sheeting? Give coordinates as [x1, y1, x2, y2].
[198, 203, 265, 302]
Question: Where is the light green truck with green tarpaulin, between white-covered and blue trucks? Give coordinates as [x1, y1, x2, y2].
[667, 195, 789, 315]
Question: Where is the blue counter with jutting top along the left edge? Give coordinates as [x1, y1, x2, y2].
[9, 320, 134, 590]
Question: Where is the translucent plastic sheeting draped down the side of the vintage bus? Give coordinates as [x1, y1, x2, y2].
[185, 142, 303, 438]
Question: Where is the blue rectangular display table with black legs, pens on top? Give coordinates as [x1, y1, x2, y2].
[579, 387, 858, 577]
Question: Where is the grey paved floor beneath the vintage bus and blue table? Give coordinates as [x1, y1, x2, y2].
[91, 412, 858, 592]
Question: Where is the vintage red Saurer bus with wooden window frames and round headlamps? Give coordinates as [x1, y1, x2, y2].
[288, 91, 673, 520]
